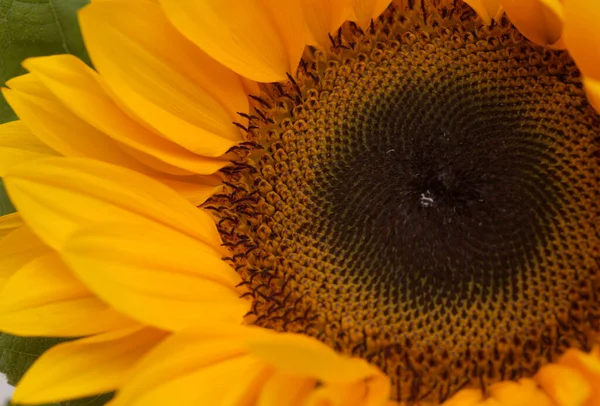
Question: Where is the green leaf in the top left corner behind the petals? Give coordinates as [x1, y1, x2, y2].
[0, 0, 89, 123]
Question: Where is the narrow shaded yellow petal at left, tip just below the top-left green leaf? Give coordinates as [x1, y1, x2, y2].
[4, 74, 151, 170]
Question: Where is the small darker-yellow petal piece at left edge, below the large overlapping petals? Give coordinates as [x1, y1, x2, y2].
[0, 225, 50, 290]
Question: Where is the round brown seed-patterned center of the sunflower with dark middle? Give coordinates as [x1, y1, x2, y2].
[207, 0, 600, 401]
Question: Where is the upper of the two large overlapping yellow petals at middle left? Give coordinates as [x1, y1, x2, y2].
[5, 158, 225, 252]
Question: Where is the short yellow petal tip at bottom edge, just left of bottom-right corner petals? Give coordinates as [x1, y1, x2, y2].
[489, 379, 553, 406]
